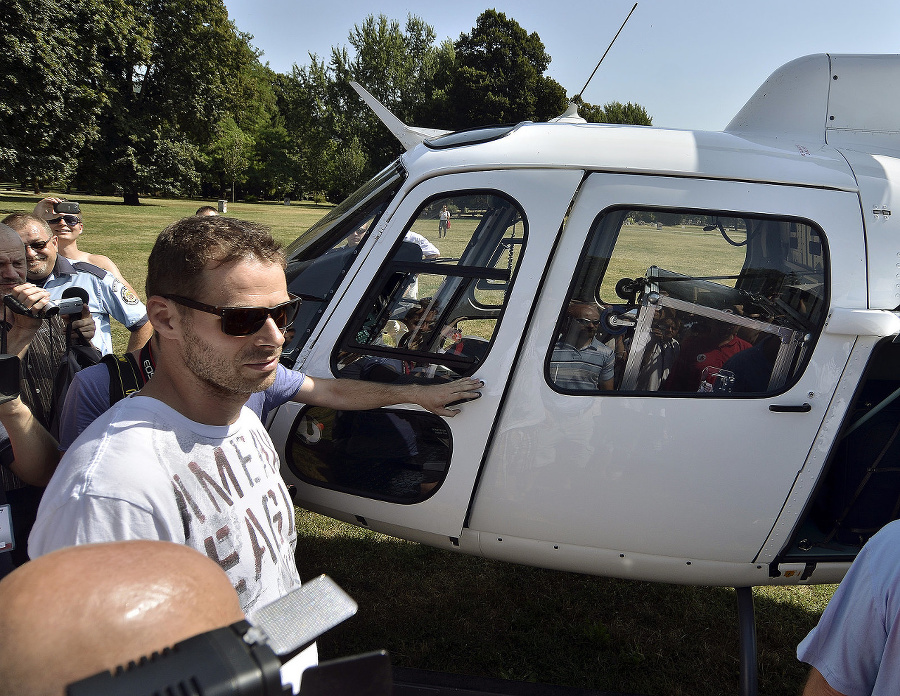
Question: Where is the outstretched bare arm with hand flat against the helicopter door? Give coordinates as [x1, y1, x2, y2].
[293, 375, 484, 418]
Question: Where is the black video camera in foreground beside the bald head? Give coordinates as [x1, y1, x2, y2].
[66, 575, 393, 696]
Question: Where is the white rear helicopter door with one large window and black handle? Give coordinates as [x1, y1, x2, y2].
[469, 174, 865, 563]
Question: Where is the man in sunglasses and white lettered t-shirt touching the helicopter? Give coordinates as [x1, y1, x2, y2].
[29, 217, 481, 611]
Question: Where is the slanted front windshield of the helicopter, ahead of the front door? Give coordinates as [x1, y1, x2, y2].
[281, 163, 404, 367]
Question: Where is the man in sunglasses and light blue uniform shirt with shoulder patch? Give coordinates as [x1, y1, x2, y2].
[5, 213, 153, 355]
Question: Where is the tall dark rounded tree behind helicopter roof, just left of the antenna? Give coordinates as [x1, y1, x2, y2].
[448, 10, 566, 129]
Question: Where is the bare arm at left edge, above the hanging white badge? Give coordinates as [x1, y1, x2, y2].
[0, 397, 60, 486]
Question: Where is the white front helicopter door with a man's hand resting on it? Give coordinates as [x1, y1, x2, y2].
[270, 170, 583, 545]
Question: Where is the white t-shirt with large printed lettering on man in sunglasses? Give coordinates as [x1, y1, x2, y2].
[28, 396, 300, 612]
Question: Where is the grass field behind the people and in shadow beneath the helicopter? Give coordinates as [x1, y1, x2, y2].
[0, 191, 834, 696]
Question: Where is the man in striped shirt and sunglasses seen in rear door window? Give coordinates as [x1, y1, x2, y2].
[550, 302, 616, 391]
